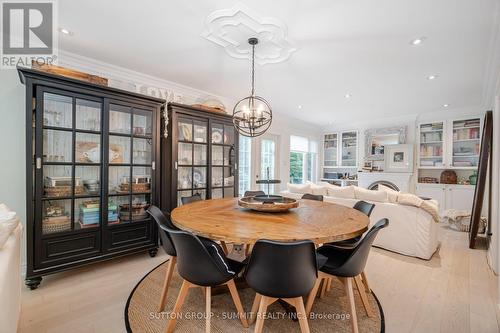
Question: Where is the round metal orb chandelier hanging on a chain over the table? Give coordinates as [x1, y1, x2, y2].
[233, 38, 273, 137]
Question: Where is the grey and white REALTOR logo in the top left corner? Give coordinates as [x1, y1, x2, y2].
[1, 1, 57, 68]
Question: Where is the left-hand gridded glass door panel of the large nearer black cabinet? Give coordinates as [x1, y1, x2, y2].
[41, 92, 102, 235]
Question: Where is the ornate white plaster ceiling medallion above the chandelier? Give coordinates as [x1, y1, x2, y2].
[202, 3, 297, 65]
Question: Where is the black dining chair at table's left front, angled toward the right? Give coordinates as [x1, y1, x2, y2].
[165, 228, 248, 333]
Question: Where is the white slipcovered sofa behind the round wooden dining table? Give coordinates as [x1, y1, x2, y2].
[281, 184, 439, 260]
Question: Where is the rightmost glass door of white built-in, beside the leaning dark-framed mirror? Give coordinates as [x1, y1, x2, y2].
[452, 118, 481, 167]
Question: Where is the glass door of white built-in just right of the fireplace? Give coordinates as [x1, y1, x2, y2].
[419, 122, 444, 168]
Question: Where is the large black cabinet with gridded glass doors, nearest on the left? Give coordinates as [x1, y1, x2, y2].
[18, 68, 164, 289]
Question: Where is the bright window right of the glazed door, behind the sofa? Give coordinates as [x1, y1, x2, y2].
[290, 135, 318, 184]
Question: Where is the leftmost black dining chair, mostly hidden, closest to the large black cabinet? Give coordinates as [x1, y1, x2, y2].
[147, 205, 179, 312]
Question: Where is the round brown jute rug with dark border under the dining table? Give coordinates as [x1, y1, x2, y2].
[125, 262, 385, 333]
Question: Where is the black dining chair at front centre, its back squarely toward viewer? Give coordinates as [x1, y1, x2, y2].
[245, 240, 318, 333]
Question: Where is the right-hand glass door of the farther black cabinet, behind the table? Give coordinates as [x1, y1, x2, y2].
[210, 122, 236, 199]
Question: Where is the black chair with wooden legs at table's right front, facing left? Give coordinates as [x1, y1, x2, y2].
[306, 219, 389, 332]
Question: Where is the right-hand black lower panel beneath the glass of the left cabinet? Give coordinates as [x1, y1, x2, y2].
[107, 221, 152, 251]
